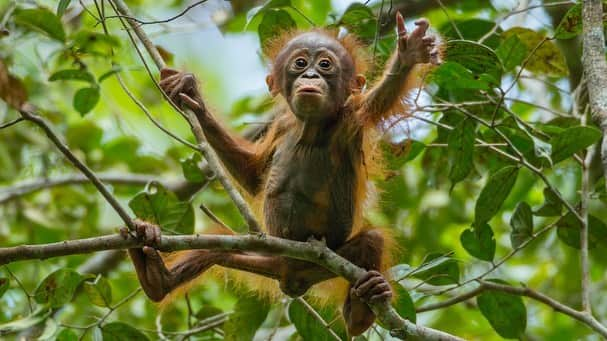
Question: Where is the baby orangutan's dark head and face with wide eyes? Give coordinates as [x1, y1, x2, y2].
[275, 32, 354, 122]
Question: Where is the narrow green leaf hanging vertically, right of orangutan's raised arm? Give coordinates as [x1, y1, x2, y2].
[447, 119, 476, 188]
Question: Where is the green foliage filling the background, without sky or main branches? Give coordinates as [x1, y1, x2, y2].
[0, 0, 607, 340]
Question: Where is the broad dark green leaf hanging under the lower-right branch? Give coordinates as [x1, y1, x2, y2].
[476, 280, 527, 339]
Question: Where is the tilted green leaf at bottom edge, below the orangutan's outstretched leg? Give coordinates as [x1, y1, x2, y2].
[223, 295, 270, 341]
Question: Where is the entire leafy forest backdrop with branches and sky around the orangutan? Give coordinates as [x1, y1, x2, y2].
[0, 0, 607, 340]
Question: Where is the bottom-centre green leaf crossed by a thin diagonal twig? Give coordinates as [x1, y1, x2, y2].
[288, 300, 347, 341]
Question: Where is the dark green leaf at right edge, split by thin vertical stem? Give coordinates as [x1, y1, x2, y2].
[556, 212, 607, 249]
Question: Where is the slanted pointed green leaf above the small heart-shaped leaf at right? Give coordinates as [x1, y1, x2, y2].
[474, 166, 518, 226]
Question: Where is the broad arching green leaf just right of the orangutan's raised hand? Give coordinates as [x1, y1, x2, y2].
[445, 40, 503, 85]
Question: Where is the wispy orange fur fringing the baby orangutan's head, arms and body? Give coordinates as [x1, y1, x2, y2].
[157, 29, 442, 314]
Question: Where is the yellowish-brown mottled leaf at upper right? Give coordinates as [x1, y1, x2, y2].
[503, 27, 569, 77]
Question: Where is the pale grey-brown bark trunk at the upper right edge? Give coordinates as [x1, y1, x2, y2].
[582, 0, 607, 191]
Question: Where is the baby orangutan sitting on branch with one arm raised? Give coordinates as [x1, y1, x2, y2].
[129, 13, 437, 335]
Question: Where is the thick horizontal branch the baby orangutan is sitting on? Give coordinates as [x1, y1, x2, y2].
[0, 234, 461, 341]
